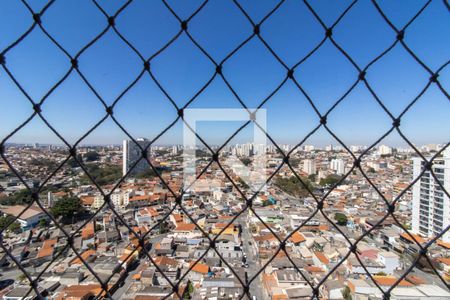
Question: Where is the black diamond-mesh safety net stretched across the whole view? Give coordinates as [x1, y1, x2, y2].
[0, 0, 450, 299]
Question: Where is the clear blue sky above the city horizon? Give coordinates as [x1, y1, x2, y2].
[0, 0, 450, 146]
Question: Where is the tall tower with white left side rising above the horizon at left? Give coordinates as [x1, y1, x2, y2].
[122, 138, 150, 176]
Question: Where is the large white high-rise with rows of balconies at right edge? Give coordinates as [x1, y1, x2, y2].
[412, 149, 450, 242]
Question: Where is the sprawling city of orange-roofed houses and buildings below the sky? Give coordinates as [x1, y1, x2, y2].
[0, 139, 450, 299]
